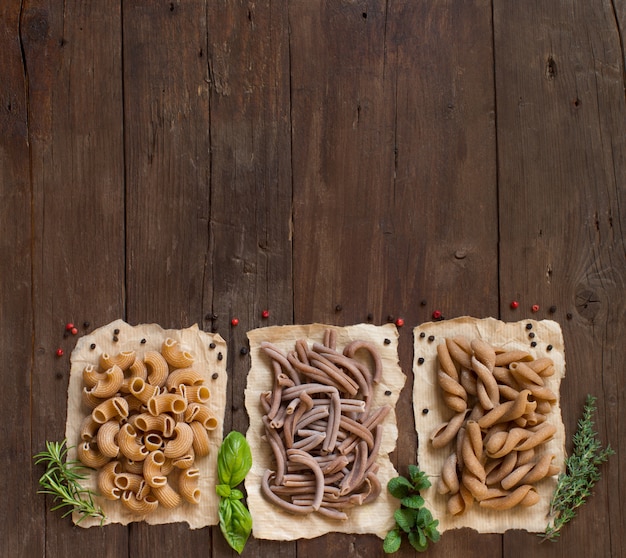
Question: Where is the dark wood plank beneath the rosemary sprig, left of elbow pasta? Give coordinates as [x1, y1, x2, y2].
[18, 1, 127, 556]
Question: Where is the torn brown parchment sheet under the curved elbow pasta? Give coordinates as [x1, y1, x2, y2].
[65, 320, 227, 529]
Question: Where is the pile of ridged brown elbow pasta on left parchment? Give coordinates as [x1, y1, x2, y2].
[77, 338, 217, 515]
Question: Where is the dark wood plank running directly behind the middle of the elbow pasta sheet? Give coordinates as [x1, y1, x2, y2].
[123, 1, 211, 557]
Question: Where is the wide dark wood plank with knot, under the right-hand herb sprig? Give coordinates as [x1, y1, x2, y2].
[494, 1, 626, 556]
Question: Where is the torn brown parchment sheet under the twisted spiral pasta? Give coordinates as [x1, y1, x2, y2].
[413, 316, 565, 533]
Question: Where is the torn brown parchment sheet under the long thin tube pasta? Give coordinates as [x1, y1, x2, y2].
[245, 324, 406, 541]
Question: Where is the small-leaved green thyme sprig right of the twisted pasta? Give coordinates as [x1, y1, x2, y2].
[540, 395, 615, 541]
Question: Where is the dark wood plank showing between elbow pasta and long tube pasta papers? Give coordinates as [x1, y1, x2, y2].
[205, 1, 295, 557]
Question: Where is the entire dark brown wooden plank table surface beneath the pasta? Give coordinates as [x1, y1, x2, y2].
[0, 0, 626, 558]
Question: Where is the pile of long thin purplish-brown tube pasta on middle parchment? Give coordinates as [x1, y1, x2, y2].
[260, 330, 390, 520]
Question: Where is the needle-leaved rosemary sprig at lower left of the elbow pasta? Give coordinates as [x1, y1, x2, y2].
[33, 440, 106, 526]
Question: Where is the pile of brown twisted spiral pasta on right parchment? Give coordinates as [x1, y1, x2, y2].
[430, 336, 559, 515]
